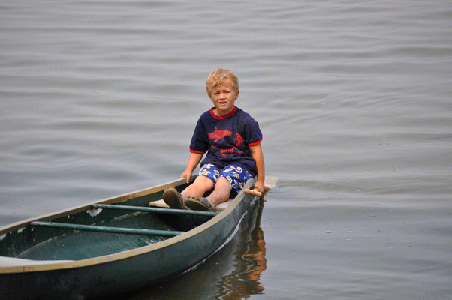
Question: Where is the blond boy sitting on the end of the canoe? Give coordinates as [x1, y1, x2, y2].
[163, 69, 265, 210]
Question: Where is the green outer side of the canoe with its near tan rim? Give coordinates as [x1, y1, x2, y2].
[0, 182, 256, 299]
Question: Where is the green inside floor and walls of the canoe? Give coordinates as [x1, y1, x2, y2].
[0, 184, 212, 260]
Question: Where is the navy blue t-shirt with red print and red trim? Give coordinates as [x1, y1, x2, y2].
[190, 106, 262, 176]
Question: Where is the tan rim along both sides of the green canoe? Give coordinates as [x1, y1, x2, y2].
[0, 176, 254, 274]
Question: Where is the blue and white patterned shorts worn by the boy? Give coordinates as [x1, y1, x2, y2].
[198, 164, 253, 193]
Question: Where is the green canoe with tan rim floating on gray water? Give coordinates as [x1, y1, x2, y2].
[0, 179, 257, 299]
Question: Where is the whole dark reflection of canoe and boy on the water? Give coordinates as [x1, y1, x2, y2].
[121, 201, 267, 300]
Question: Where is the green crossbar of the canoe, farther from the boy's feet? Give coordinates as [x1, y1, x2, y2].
[30, 221, 184, 236]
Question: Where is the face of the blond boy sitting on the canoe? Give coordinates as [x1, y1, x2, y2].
[209, 80, 239, 116]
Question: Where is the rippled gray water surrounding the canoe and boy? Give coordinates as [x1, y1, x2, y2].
[0, 0, 452, 299]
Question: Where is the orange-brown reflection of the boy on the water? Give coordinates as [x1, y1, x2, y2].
[216, 201, 267, 300]
